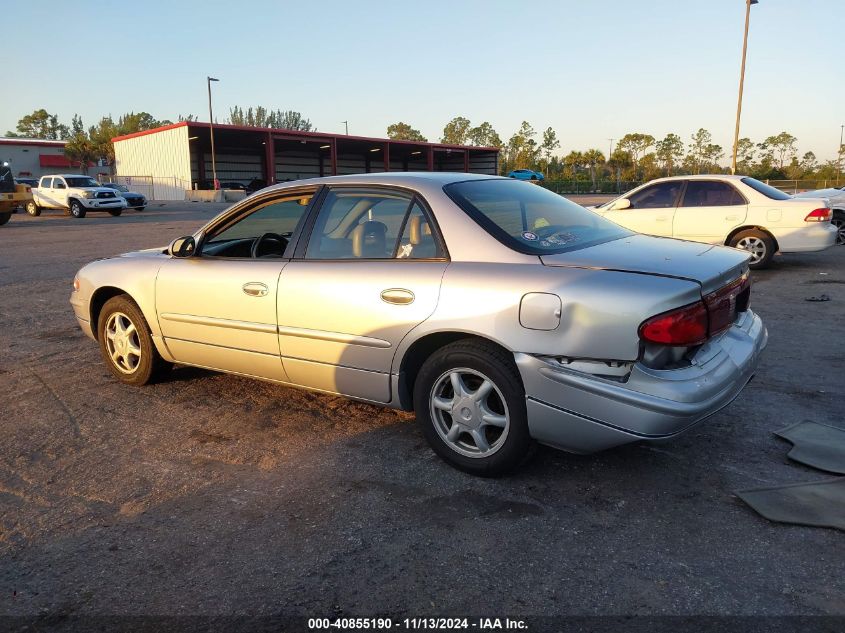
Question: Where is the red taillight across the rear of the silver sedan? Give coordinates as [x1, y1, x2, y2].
[640, 273, 751, 347]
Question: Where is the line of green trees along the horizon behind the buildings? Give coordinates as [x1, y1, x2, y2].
[6, 106, 845, 181]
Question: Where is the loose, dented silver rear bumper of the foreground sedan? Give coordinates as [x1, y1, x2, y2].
[515, 310, 768, 453]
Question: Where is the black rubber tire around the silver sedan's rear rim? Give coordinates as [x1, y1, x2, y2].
[414, 341, 532, 477]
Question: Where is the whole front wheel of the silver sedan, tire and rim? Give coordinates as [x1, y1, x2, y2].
[97, 295, 172, 385]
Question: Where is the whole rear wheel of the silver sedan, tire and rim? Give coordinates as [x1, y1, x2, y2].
[414, 341, 531, 477]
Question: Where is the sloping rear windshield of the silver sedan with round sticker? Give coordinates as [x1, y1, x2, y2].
[444, 178, 631, 255]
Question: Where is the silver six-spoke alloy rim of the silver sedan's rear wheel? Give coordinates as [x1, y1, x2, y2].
[429, 367, 510, 458]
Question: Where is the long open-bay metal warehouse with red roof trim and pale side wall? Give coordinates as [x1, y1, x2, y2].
[112, 121, 499, 200]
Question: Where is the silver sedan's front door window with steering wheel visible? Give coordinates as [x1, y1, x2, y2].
[202, 192, 313, 257]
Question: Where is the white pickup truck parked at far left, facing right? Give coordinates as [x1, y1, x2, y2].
[26, 174, 128, 218]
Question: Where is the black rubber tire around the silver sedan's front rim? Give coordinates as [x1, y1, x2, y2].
[97, 295, 173, 385]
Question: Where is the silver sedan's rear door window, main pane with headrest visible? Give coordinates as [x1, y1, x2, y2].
[305, 188, 413, 259]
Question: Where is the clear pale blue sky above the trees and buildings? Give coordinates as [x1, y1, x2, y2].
[6, 0, 845, 160]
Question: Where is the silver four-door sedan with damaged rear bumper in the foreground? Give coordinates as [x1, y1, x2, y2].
[70, 173, 767, 475]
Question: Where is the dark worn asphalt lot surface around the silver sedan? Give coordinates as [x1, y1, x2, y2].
[0, 201, 845, 617]
